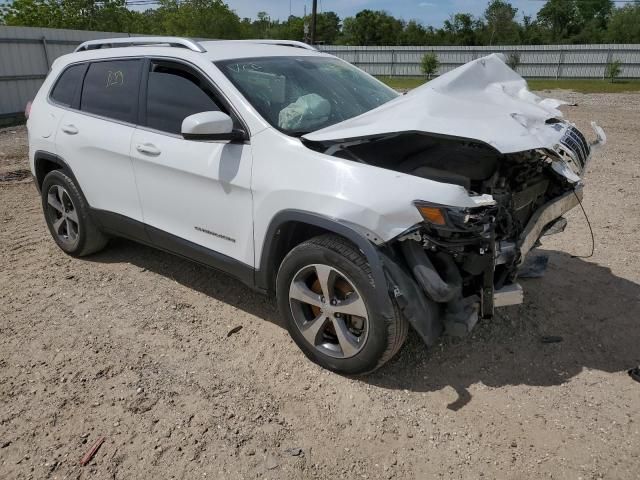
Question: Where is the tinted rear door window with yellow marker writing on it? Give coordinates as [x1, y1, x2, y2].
[80, 60, 142, 123]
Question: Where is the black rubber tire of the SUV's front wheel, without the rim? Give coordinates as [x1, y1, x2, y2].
[276, 234, 409, 375]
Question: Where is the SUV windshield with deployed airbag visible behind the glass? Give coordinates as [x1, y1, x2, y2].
[216, 56, 398, 136]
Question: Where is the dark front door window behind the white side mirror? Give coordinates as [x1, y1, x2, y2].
[146, 61, 222, 134]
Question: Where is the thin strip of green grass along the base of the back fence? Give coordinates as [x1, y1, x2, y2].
[378, 77, 640, 93]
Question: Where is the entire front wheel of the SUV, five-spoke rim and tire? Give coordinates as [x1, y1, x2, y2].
[276, 235, 408, 374]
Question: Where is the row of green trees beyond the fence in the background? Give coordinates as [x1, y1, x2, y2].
[0, 0, 640, 45]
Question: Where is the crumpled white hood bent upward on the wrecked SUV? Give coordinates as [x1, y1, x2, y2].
[303, 54, 564, 153]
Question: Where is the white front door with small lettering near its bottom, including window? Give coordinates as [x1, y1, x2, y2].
[131, 59, 254, 270]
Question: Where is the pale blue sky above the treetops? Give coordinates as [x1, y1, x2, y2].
[225, 0, 544, 27]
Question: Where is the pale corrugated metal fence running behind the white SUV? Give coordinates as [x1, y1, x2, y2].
[0, 27, 640, 120]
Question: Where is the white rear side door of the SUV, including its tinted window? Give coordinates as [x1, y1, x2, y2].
[51, 59, 143, 221]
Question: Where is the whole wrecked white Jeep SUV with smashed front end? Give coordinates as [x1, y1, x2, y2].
[28, 37, 605, 374]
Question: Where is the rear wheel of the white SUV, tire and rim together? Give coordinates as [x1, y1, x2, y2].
[41, 170, 108, 257]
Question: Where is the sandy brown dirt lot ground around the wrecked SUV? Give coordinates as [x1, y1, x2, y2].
[0, 92, 640, 479]
